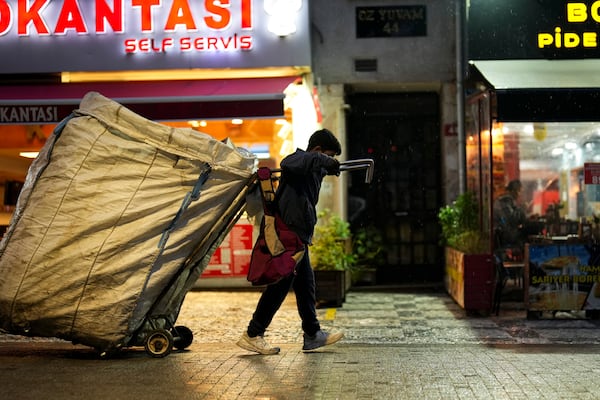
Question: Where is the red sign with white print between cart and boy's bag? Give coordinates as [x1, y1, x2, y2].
[202, 223, 254, 278]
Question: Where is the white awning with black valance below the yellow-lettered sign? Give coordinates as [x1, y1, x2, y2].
[471, 59, 600, 122]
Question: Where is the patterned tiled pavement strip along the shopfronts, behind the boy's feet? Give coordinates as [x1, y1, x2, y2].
[179, 288, 600, 346]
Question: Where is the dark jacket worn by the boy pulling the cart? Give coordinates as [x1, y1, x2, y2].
[277, 149, 340, 243]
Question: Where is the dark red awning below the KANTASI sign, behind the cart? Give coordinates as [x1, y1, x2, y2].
[0, 77, 298, 124]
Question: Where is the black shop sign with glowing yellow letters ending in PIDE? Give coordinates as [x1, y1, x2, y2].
[468, 0, 600, 60]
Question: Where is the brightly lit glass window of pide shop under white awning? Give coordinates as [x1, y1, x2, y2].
[493, 122, 600, 234]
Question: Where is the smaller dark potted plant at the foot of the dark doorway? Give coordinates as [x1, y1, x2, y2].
[352, 225, 385, 285]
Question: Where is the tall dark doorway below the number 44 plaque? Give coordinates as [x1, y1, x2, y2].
[346, 93, 443, 284]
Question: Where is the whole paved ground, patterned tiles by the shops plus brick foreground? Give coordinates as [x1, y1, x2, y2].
[0, 290, 600, 400]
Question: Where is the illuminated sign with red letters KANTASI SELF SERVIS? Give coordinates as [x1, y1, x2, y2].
[0, 0, 253, 53]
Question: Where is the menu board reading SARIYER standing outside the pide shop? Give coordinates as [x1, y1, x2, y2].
[525, 242, 600, 311]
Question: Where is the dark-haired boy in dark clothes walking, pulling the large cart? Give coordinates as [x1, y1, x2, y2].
[237, 129, 344, 354]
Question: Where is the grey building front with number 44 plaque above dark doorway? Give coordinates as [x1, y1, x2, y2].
[311, 0, 459, 285]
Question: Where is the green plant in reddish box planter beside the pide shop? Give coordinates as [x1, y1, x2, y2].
[438, 192, 496, 313]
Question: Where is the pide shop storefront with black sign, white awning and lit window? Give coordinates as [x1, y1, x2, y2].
[465, 0, 600, 311]
